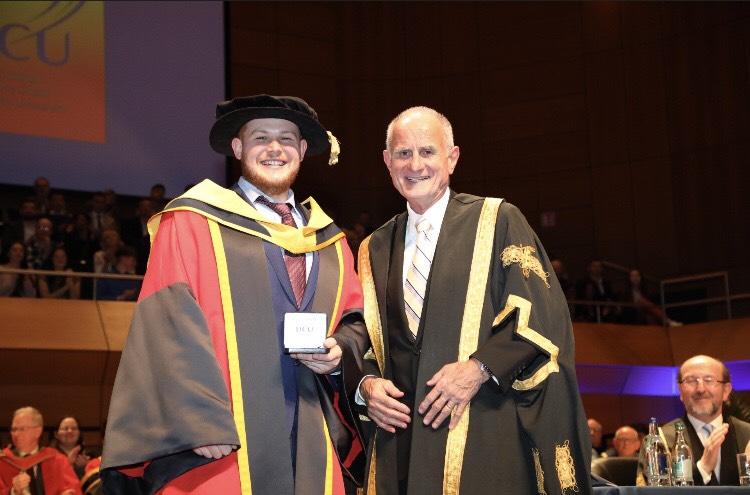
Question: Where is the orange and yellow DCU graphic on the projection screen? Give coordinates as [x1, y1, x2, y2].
[0, 1, 106, 143]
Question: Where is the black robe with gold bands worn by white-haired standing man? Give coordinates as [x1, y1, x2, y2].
[337, 192, 591, 495]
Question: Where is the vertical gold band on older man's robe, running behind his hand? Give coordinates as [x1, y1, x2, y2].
[444, 198, 502, 495]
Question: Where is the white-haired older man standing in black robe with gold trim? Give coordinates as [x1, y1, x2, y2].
[336, 107, 591, 495]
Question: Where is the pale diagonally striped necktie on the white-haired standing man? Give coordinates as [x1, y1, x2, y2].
[404, 218, 435, 337]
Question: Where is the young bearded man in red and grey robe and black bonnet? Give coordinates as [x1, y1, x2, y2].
[101, 95, 362, 495]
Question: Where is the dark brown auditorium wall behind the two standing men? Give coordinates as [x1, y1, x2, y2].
[228, 2, 750, 292]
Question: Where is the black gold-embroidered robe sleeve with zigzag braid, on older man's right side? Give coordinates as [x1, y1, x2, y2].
[475, 203, 591, 495]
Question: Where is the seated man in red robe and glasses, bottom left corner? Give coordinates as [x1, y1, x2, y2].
[0, 407, 81, 495]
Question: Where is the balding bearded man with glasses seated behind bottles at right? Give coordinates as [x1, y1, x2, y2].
[638, 356, 750, 486]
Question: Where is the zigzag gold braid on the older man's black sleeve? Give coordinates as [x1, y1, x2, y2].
[492, 294, 560, 390]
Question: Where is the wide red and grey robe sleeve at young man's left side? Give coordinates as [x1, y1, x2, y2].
[102, 212, 239, 493]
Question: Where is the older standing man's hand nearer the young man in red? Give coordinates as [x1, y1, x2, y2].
[360, 376, 411, 433]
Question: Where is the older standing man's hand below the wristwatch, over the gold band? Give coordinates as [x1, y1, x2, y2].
[418, 358, 490, 429]
